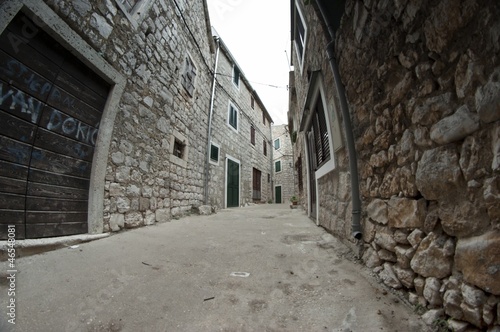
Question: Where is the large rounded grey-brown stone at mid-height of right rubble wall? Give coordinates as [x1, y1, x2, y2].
[416, 147, 463, 200]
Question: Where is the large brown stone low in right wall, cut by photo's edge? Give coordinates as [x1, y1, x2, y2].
[455, 231, 500, 295]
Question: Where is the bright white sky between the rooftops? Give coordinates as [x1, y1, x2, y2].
[207, 0, 290, 125]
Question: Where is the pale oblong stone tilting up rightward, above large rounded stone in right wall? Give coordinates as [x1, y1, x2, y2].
[431, 105, 479, 145]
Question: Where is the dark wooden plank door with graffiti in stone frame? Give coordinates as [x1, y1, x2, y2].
[0, 14, 109, 239]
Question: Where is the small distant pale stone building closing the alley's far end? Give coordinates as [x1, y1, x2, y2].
[272, 125, 296, 204]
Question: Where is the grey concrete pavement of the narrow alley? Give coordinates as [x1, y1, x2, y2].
[0, 205, 428, 332]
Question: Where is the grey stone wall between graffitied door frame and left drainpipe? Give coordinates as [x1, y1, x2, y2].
[42, 0, 213, 231]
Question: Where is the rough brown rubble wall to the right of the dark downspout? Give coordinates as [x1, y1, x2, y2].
[330, 0, 500, 331]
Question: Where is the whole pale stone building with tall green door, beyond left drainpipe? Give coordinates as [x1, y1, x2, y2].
[209, 36, 272, 208]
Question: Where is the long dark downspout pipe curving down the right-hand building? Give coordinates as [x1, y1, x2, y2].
[316, 0, 363, 240]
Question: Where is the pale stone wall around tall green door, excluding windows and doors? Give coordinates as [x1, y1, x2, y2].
[209, 41, 272, 208]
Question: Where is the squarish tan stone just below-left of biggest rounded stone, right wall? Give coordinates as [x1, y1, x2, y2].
[387, 196, 427, 228]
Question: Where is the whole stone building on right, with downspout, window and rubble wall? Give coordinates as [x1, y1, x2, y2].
[289, 0, 500, 331]
